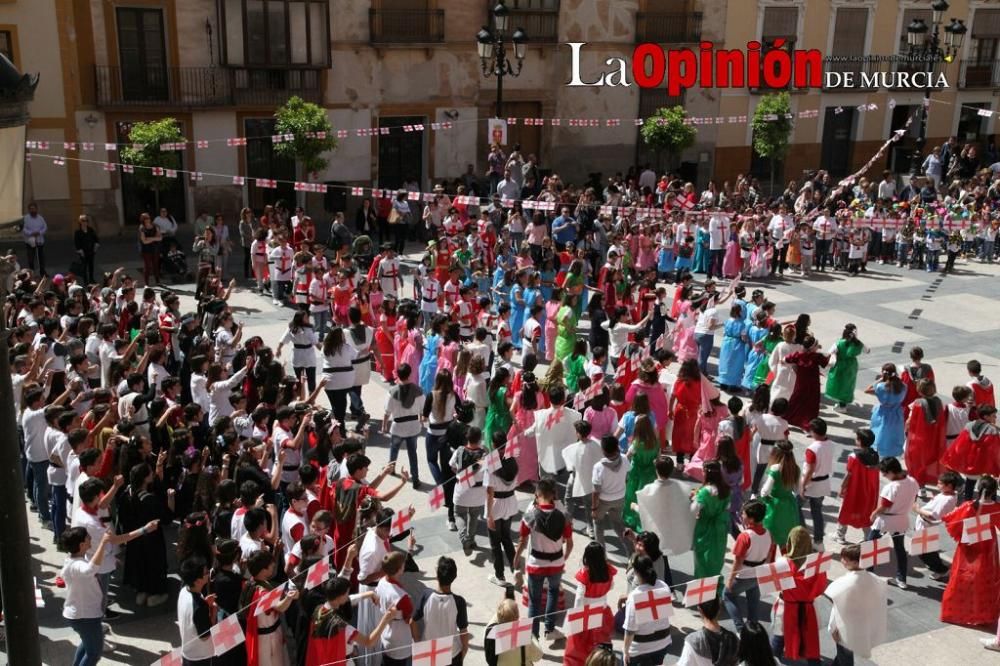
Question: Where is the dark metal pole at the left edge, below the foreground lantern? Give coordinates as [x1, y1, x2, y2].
[0, 261, 42, 666]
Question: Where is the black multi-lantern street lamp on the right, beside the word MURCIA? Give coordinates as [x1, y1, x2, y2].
[906, 0, 968, 179]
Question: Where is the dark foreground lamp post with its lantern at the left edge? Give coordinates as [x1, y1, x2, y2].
[0, 55, 42, 666]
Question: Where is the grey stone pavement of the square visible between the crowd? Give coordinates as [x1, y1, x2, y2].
[8, 246, 1000, 664]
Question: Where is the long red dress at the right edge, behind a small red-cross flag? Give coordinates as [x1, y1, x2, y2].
[941, 502, 1000, 626]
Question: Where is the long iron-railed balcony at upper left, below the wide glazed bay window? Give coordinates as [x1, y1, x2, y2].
[94, 65, 323, 109]
